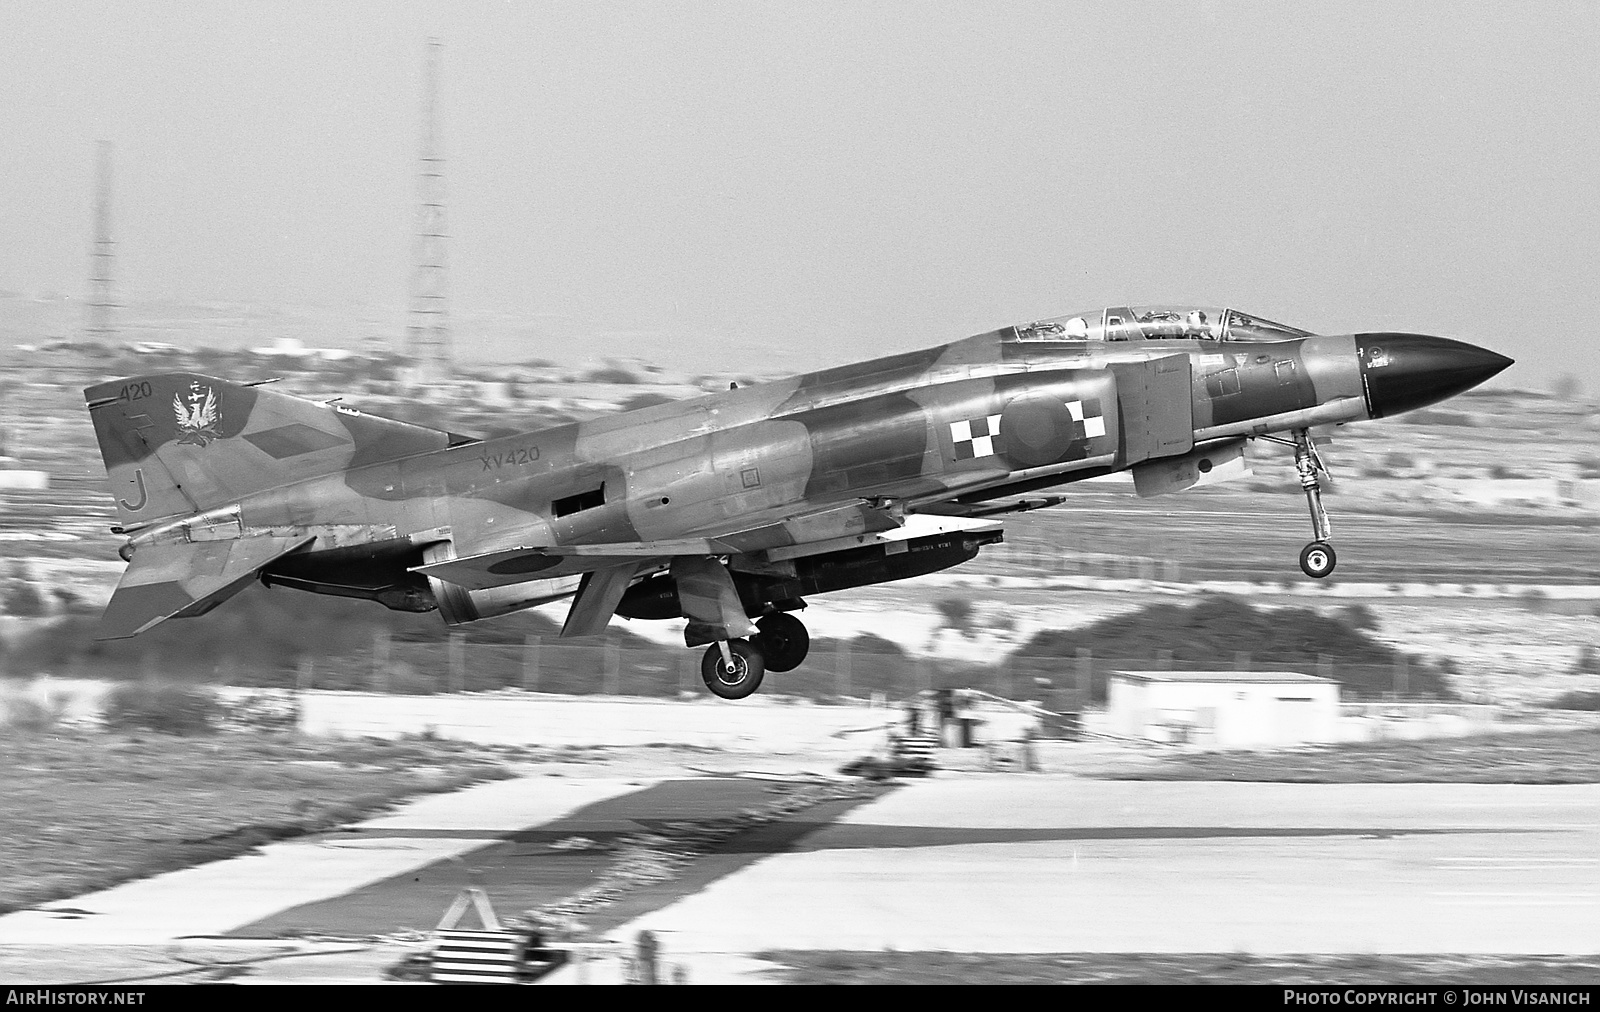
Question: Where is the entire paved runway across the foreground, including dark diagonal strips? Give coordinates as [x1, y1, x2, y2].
[0, 772, 1600, 983]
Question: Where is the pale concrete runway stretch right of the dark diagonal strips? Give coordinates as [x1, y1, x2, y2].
[608, 775, 1600, 954]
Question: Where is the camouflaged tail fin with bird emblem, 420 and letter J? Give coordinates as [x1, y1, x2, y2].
[83, 373, 467, 530]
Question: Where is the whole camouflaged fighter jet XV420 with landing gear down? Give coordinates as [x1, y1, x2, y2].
[85, 306, 1512, 700]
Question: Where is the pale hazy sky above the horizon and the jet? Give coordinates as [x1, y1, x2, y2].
[0, 0, 1600, 392]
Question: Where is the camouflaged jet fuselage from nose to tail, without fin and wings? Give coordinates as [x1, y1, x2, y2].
[109, 302, 1507, 618]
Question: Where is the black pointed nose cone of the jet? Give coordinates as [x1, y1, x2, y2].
[1355, 333, 1512, 418]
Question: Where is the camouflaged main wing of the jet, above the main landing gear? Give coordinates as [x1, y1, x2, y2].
[416, 500, 901, 591]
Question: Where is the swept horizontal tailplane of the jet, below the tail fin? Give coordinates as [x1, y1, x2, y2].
[96, 535, 315, 639]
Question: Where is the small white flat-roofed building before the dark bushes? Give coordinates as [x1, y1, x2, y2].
[1106, 671, 1339, 748]
